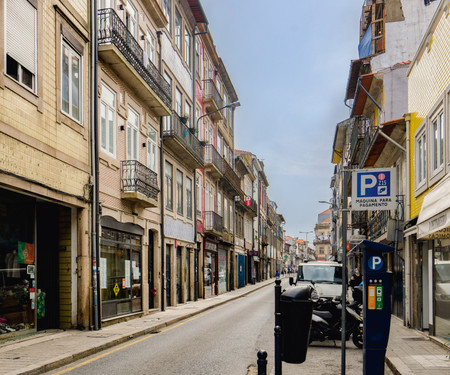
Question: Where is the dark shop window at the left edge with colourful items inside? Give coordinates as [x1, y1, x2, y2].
[0, 189, 36, 337]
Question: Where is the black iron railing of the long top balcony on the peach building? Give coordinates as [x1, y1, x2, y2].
[98, 9, 172, 108]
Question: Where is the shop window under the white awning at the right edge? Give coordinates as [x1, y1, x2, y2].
[434, 240, 450, 339]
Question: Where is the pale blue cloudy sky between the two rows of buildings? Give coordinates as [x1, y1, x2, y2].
[201, 0, 363, 244]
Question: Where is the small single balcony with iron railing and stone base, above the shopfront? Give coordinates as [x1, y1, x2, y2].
[121, 160, 159, 208]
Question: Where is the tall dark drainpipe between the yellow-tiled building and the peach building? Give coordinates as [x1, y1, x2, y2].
[91, 0, 100, 331]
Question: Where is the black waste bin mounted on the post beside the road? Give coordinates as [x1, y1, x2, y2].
[280, 285, 314, 363]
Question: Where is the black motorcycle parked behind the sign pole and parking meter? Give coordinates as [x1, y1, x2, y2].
[309, 297, 363, 349]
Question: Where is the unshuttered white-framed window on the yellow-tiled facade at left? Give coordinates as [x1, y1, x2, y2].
[61, 39, 82, 122]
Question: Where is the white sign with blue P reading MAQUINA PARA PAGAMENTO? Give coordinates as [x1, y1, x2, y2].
[352, 168, 397, 211]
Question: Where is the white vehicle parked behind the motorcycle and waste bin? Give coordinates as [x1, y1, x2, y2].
[289, 261, 342, 298]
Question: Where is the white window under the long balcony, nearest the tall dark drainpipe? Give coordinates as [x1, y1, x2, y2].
[100, 84, 116, 156]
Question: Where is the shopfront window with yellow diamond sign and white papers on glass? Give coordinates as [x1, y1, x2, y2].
[100, 228, 142, 318]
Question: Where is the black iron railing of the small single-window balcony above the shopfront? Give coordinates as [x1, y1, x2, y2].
[121, 160, 159, 200]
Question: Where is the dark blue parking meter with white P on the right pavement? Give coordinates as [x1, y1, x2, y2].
[359, 240, 394, 375]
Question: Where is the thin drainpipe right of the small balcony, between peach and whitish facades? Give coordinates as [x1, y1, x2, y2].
[156, 31, 165, 311]
